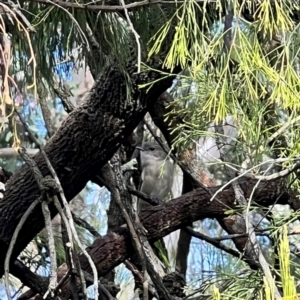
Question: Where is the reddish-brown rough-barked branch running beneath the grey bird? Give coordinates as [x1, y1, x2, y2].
[53, 179, 292, 298]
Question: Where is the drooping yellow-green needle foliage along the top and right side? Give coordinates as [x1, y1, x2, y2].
[2, 0, 300, 300]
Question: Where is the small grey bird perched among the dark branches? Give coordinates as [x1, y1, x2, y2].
[136, 142, 174, 212]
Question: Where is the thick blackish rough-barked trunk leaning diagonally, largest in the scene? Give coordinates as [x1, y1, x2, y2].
[0, 55, 176, 276]
